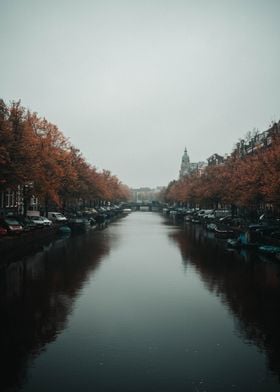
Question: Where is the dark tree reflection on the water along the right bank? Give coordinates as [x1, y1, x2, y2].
[169, 225, 280, 379]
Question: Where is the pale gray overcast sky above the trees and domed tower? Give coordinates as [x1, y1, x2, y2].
[0, 0, 280, 187]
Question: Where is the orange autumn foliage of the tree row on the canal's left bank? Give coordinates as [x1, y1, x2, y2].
[0, 100, 129, 206]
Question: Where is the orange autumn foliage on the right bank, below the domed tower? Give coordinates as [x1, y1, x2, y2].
[165, 136, 280, 208]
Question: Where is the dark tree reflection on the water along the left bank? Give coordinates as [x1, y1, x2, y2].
[0, 232, 114, 391]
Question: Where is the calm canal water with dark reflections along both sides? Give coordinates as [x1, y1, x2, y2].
[0, 212, 280, 392]
